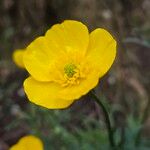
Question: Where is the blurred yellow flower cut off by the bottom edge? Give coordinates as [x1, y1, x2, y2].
[10, 135, 44, 150]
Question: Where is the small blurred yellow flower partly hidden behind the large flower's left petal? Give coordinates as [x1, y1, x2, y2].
[13, 49, 25, 68]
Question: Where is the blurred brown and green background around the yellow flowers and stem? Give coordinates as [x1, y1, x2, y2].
[0, 0, 150, 150]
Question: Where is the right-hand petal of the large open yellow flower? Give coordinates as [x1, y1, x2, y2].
[87, 28, 116, 77]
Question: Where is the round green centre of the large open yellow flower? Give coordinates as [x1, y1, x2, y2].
[64, 63, 77, 78]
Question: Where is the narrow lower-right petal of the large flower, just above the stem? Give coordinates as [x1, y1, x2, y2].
[59, 69, 99, 100]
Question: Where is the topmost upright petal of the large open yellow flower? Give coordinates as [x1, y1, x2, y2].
[46, 20, 89, 55]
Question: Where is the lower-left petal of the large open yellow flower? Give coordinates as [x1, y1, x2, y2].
[24, 77, 73, 109]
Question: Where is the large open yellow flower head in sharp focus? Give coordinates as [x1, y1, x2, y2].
[23, 20, 116, 109]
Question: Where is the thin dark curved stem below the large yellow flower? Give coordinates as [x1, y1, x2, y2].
[91, 92, 115, 148]
